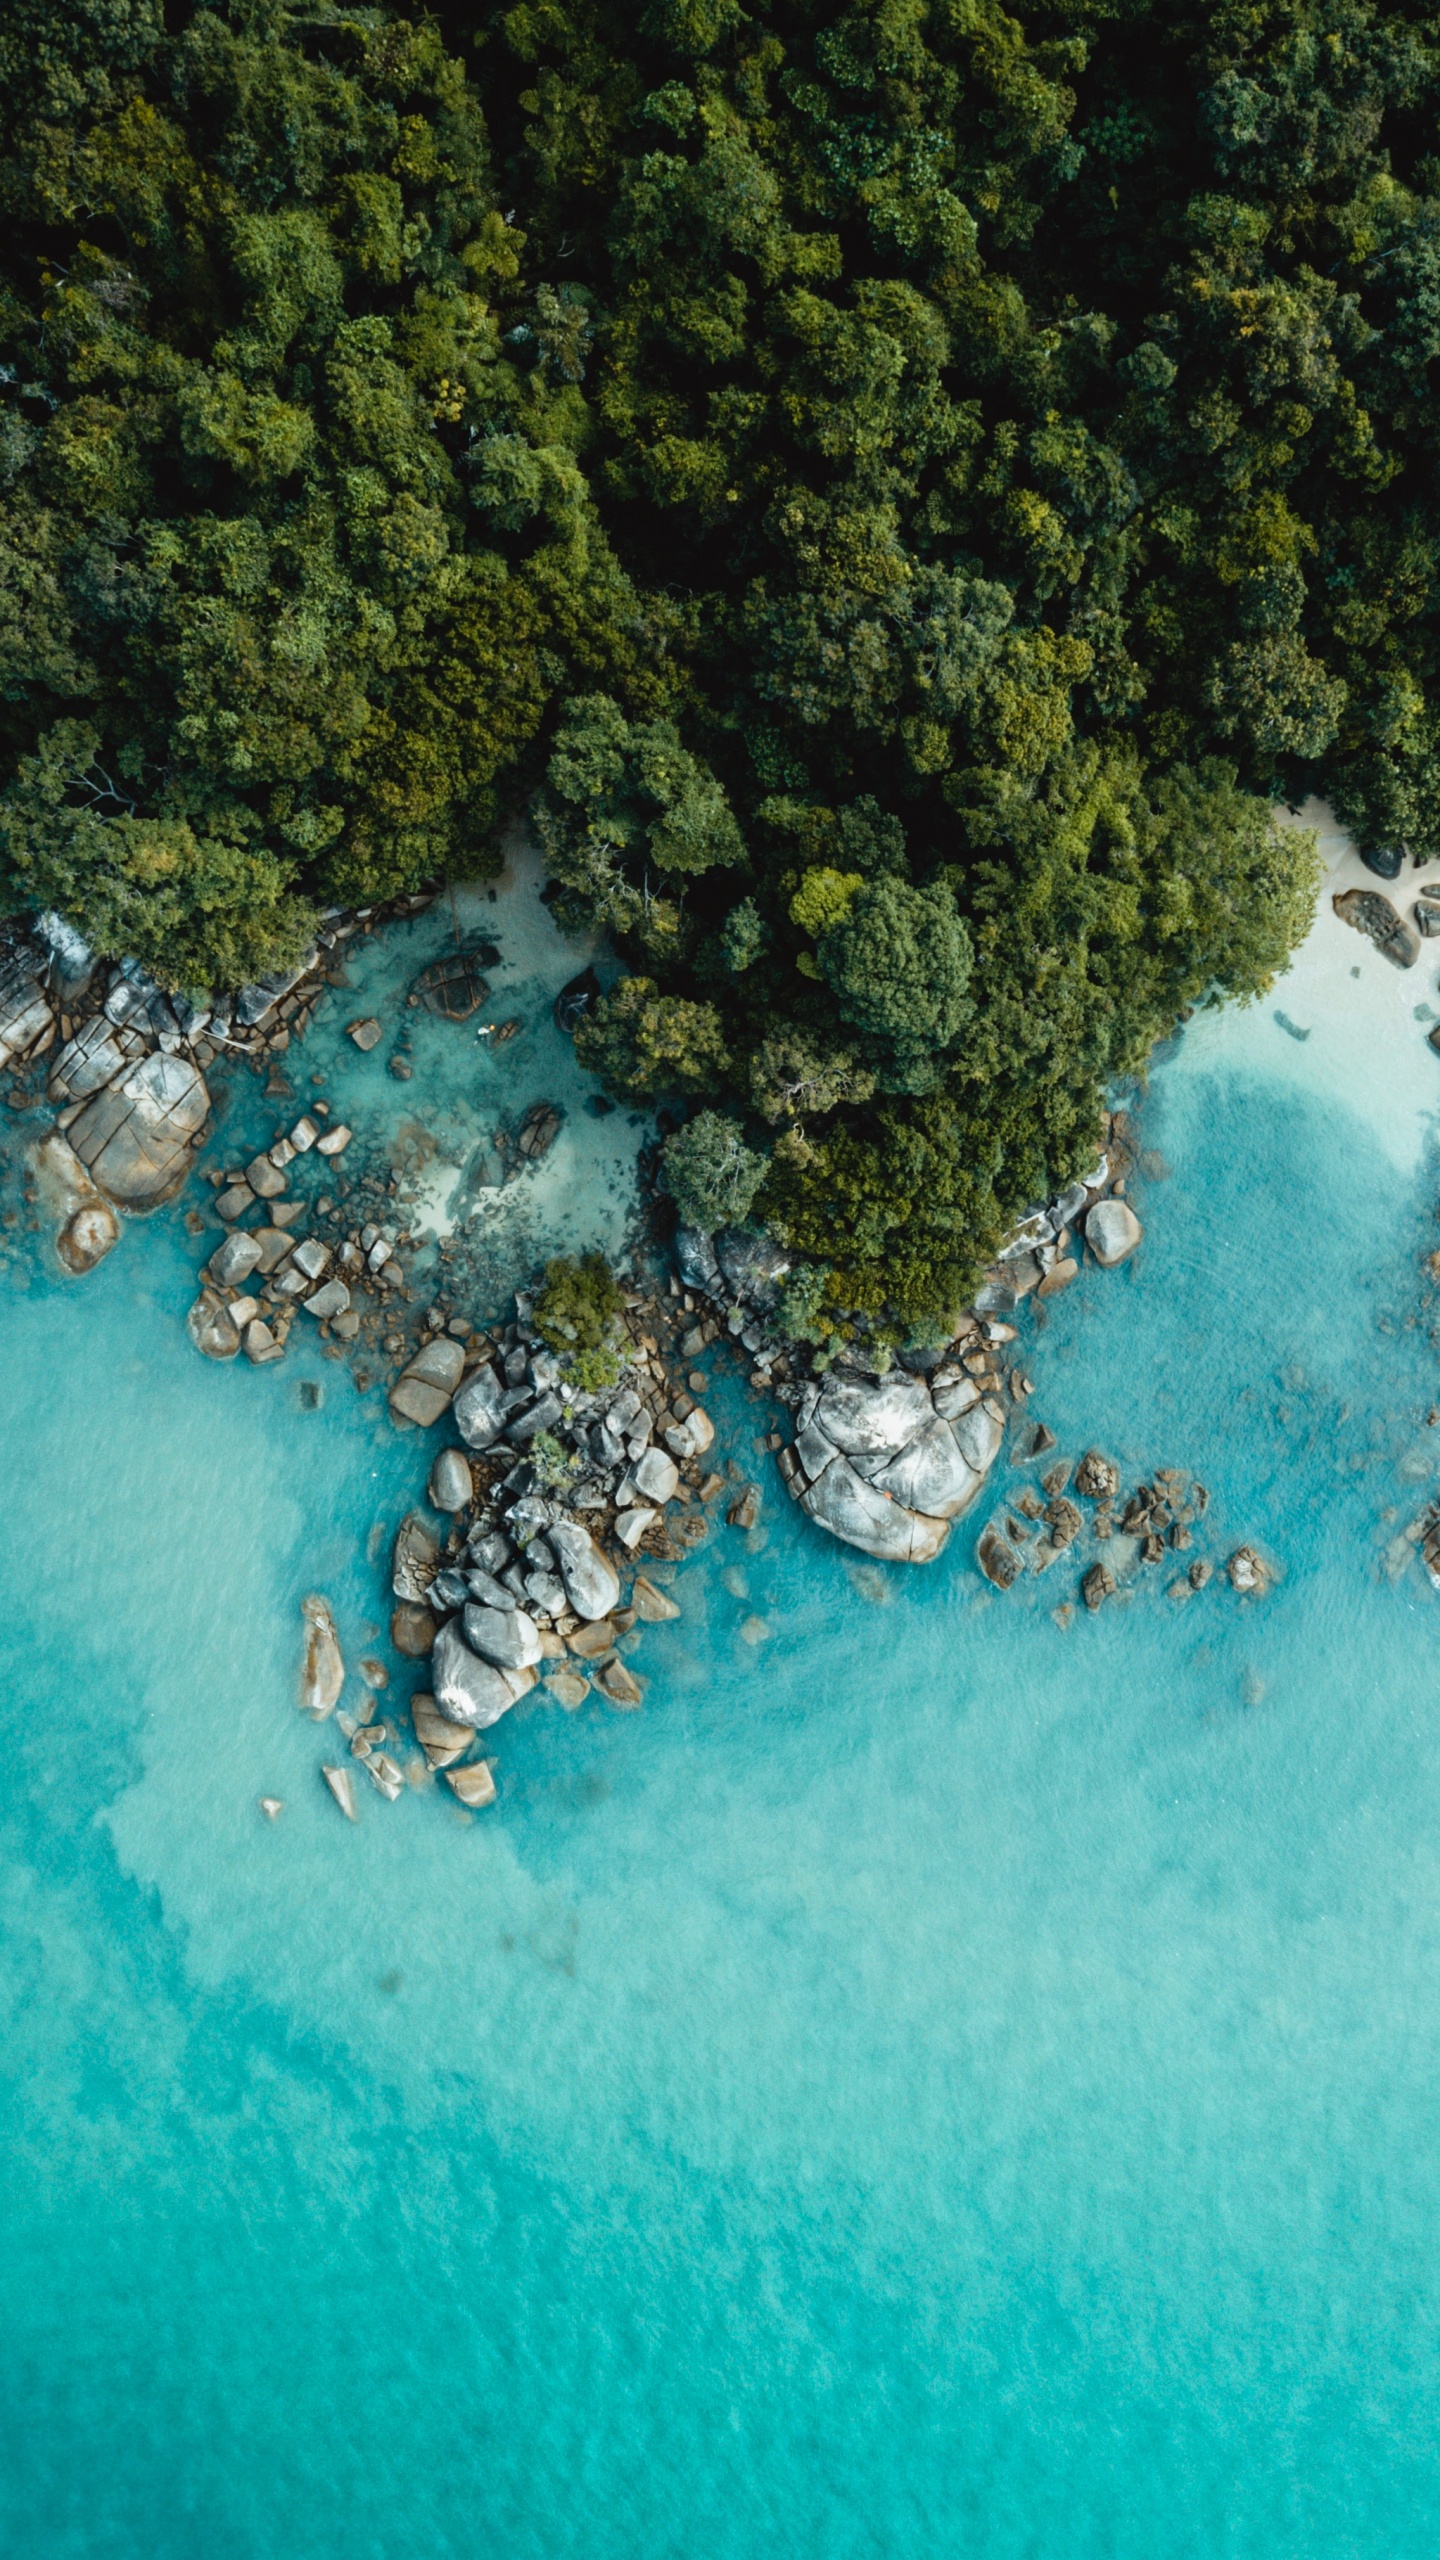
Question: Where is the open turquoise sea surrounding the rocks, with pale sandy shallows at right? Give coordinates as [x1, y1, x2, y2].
[0, 844, 1440, 2560]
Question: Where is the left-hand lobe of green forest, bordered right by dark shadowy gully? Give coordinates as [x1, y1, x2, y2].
[0, 0, 635, 983]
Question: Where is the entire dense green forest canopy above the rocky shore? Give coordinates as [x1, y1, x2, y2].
[11, 0, 1440, 1336]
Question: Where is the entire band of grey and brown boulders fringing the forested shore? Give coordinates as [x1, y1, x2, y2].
[0, 901, 1273, 1818]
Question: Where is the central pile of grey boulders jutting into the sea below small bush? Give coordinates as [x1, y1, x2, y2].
[302, 1293, 732, 1815]
